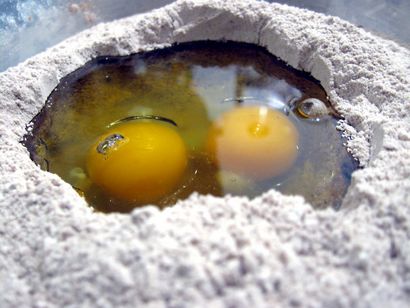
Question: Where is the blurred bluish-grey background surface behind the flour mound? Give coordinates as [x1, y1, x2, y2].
[0, 0, 410, 72]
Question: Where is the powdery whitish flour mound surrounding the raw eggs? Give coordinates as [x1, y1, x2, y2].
[0, 1, 410, 307]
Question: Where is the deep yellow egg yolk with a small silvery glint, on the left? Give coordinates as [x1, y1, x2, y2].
[87, 121, 187, 203]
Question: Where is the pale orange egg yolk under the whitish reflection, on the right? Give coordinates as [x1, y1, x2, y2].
[207, 106, 299, 181]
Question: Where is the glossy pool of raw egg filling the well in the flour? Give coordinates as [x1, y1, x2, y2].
[25, 42, 356, 212]
